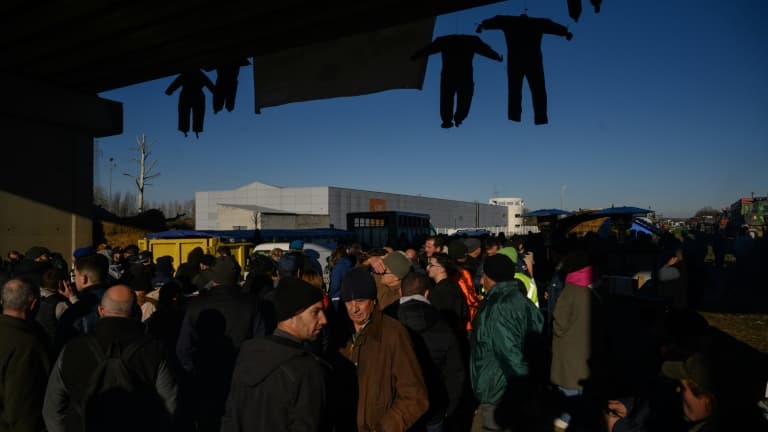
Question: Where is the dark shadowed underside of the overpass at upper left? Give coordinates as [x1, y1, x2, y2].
[0, 0, 499, 94]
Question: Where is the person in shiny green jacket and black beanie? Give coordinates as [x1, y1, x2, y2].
[469, 254, 544, 432]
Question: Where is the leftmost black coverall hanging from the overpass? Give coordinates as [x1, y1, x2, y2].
[165, 69, 214, 136]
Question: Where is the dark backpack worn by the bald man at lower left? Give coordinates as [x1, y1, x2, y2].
[80, 336, 153, 431]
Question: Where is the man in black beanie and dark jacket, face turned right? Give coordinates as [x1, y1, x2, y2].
[221, 276, 328, 432]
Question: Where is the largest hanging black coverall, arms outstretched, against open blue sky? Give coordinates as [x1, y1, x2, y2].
[477, 15, 573, 125]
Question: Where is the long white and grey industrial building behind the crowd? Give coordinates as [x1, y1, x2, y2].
[195, 182, 536, 234]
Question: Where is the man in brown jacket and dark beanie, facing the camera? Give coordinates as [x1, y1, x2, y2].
[341, 268, 429, 432]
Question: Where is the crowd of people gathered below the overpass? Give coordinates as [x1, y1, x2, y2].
[0, 226, 760, 432]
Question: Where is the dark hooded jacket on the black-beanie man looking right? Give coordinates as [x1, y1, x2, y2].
[221, 335, 328, 432]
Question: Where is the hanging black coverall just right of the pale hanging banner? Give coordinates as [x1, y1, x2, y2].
[411, 35, 503, 128]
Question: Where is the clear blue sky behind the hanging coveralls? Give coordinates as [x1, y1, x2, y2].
[96, 0, 768, 217]
